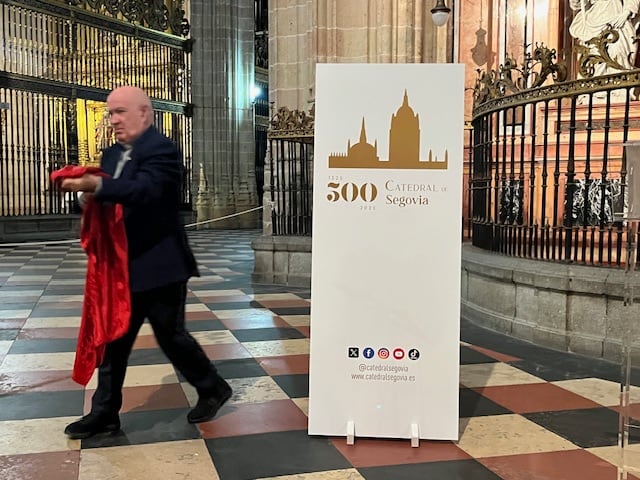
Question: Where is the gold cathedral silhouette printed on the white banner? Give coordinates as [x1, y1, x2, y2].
[329, 90, 449, 170]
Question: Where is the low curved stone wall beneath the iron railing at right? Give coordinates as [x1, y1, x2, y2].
[460, 245, 640, 361]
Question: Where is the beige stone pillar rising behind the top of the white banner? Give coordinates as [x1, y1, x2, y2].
[269, 0, 436, 110]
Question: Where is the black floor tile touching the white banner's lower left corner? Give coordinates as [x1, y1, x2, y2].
[206, 430, 350, 480]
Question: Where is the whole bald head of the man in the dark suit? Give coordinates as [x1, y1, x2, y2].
[107, 85, 153, 144]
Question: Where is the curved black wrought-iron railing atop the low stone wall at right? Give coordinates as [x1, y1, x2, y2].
[469, 70, 640, 266]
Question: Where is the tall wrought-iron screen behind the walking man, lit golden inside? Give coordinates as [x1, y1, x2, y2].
[0, 0, 192, 217]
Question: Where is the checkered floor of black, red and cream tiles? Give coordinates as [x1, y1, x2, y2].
[0, 231, 640, 480]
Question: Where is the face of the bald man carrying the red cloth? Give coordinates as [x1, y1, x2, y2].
[107, 90, 147, 144]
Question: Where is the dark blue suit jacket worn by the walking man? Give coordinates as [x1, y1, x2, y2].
[94, 126, 198, 292]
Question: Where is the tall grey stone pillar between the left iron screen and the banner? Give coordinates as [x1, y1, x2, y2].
[190, 0, 259, 228]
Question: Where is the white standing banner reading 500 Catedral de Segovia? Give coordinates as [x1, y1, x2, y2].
[309, 64, 464, 440]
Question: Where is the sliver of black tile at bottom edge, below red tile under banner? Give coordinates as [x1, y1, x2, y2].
[358, 460, 502, 480]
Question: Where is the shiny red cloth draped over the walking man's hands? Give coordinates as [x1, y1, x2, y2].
[51, 165, 131, 385]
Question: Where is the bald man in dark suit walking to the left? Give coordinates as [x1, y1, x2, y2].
[61, 86, 232, 439]
